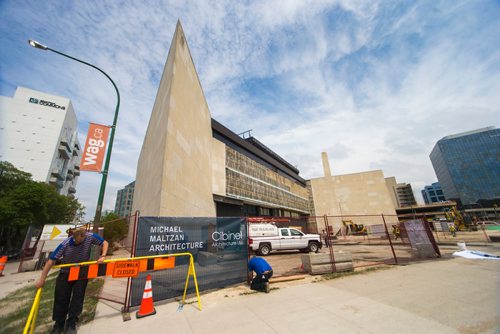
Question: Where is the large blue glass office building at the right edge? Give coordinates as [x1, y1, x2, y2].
[430, 127, 500, 205]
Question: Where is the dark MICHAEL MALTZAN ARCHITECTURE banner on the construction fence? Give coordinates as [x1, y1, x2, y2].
[131, 217, 248, 306]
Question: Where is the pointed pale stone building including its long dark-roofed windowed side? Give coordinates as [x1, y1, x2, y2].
[132, 23, 309, 223]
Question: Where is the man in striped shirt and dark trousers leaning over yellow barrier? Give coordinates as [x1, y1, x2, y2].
[35, 228, 108, 333]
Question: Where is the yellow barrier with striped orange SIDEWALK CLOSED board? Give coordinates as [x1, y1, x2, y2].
[23, 253, 201, 334]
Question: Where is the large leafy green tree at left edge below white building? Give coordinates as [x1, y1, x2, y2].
[0, 161, 83, 249]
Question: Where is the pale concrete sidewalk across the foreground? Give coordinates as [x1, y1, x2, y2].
[79, 246, 500, 334]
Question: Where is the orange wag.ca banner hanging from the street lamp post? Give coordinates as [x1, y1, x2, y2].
[80, 123, 110, 172]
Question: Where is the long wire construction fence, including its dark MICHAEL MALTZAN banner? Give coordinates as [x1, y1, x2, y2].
[19, 213, 500, 309]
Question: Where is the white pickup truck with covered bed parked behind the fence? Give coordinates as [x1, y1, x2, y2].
[248, 224, 322, 256]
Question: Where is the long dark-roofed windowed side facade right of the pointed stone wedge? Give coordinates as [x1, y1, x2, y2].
[212, 120, 309, 218]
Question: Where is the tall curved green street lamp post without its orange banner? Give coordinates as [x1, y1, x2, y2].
[28, 39, 120, 233]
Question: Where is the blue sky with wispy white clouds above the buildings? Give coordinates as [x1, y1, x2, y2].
[0, 0, 500, 219]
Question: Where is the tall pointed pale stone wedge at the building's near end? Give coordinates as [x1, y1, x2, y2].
[132, 22, 215, 217]
